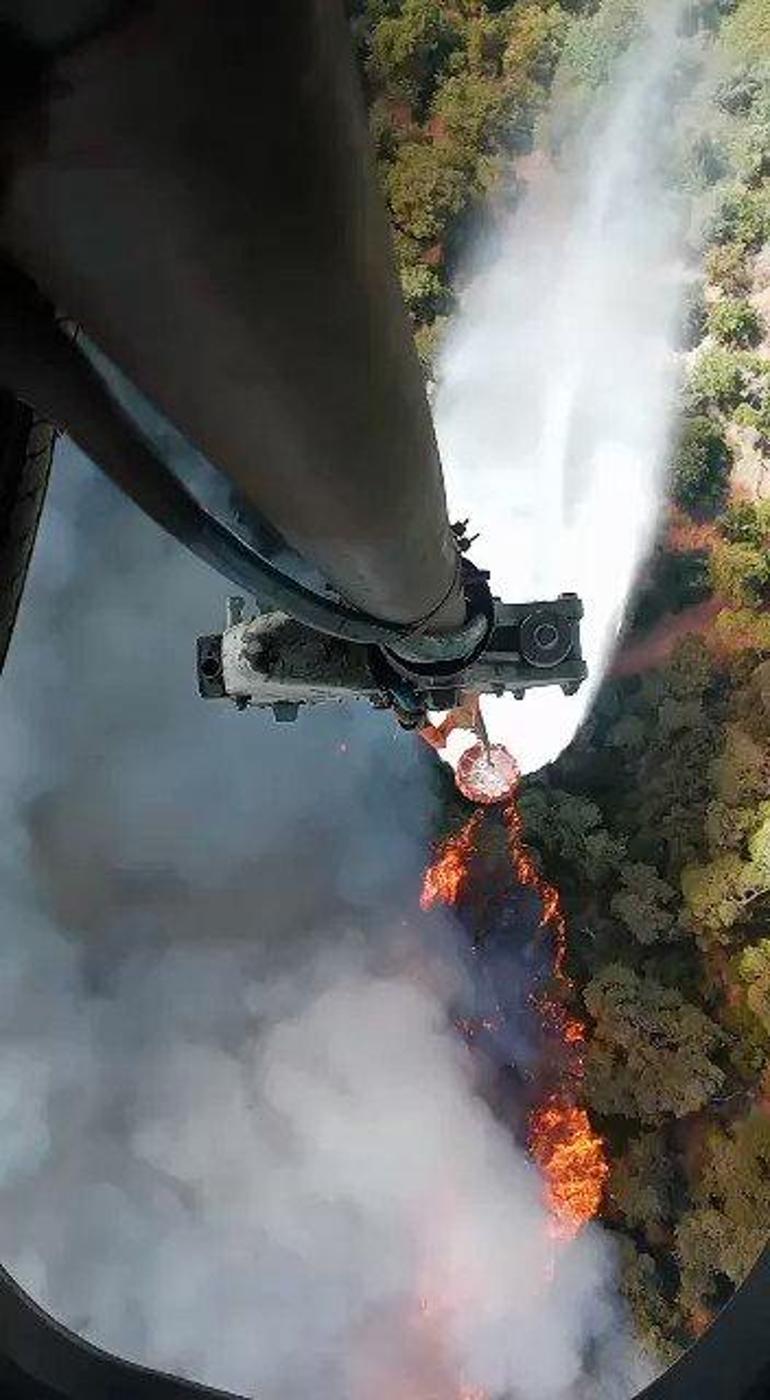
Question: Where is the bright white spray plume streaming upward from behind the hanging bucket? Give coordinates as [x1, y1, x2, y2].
[435, 3, 682, 771]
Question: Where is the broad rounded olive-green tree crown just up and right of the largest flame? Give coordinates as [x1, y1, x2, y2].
[584, 963, 724, 1123]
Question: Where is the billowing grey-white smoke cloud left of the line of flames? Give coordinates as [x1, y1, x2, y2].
[0, 445, 652, 1400]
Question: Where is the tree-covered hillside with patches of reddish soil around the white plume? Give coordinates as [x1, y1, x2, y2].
[351, 0, 770, 1359]
